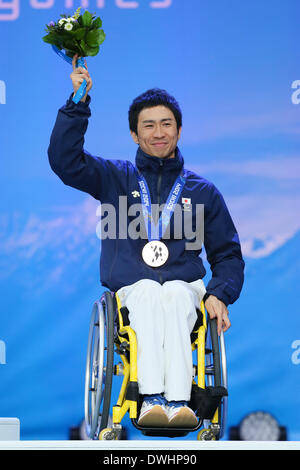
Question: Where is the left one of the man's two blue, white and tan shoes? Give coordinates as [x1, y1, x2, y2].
[138, 394, 169, 427]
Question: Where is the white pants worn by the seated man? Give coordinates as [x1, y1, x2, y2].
[118, 279, 206, 401]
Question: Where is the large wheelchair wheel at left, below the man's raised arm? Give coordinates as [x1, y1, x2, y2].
[84, 292, 114, 439]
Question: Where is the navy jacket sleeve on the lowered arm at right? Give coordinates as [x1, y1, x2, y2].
[204, 185, 245, 306]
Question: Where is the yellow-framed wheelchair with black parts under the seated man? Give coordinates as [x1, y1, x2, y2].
[84, 291, 228, 440]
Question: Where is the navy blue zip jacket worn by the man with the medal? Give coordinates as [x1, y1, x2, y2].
[48, 95, 244, 305]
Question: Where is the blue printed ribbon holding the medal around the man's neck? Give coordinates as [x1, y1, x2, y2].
[136, 169, 186, 241]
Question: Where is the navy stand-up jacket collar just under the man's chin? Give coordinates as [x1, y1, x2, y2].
[135, 147, 184, 172]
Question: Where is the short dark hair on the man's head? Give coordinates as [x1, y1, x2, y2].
[128, 88, 182, 134]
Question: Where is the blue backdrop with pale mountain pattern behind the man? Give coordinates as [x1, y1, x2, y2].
[0, 0, 300, 440]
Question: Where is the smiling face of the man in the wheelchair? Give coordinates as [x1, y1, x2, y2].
[131, 105, 181, 158]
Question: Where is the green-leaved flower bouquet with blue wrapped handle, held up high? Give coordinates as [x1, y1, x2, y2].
[43, 7, 105, 103]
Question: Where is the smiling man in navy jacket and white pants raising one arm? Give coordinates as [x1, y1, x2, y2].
[48, 56, 244, 426]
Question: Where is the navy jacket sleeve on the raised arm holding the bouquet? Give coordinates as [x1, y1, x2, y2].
[48, 94, 116, 200]
